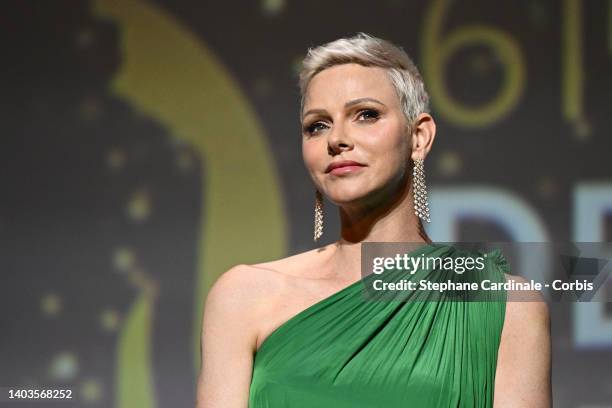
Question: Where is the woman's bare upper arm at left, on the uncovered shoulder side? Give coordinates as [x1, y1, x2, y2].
[196, 265, 256, 408]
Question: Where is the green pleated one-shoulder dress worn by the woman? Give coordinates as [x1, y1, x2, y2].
[249, 244, 508, 408]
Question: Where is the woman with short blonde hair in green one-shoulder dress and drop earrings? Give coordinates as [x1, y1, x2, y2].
[197, 33, 551, 408]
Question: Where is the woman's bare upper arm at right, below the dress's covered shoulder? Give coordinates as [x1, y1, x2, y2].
[493, 277, 552, 408]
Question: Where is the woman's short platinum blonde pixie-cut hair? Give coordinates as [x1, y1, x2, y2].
[299, 32, 430, 126]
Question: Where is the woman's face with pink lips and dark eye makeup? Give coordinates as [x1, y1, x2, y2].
[302, 64, 411, 205]
